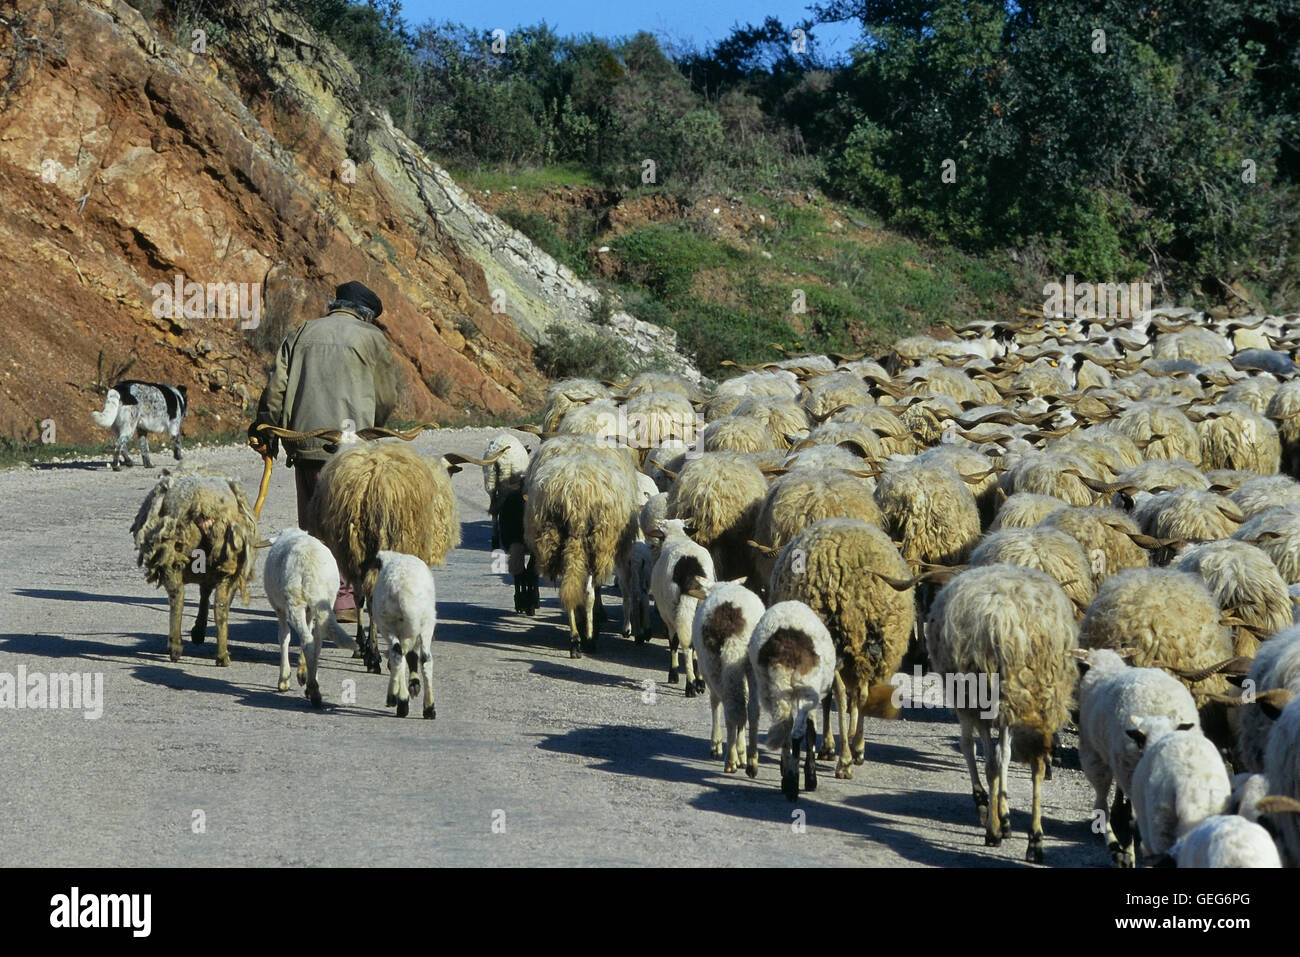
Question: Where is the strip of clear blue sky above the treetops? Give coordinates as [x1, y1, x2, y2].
[402, 0, 859, 59]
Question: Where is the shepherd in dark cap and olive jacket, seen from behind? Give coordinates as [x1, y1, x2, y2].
[248, 282, 398, 622]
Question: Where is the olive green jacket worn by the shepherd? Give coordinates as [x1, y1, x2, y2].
[255, 307, 398, 464]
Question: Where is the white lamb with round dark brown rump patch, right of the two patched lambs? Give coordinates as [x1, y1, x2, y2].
[749, 601, 835, 801]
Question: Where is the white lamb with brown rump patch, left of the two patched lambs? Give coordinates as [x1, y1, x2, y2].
[690, 580, 763, 778]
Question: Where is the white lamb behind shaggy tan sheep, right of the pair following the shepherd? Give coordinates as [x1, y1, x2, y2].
[373, 551, 438, 718]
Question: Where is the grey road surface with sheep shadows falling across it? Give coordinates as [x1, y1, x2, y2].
[0, 429, 1109, 867]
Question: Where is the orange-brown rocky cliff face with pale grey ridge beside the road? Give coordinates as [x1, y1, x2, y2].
[0, 0, 686, 441]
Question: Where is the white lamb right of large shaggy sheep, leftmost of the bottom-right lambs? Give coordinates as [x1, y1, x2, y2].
[1079, 649, 1199, 867]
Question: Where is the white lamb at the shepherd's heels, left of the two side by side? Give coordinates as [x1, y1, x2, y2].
[263, 528, 356, 707]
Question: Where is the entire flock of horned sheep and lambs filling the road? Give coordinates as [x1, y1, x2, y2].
[124, 308, 1300, 866]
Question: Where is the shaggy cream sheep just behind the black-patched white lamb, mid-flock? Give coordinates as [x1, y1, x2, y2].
[668, 452, 767, 581]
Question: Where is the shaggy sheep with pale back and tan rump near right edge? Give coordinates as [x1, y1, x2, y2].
[1171, 540, 1292, 658]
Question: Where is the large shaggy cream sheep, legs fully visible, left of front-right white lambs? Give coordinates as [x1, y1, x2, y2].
[926, 564, 1078, 863]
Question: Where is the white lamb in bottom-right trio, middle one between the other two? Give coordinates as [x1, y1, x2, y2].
[1128, 715, 1232, 866]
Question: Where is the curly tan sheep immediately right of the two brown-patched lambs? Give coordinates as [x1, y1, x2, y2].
[768, 519, 915, 778]
